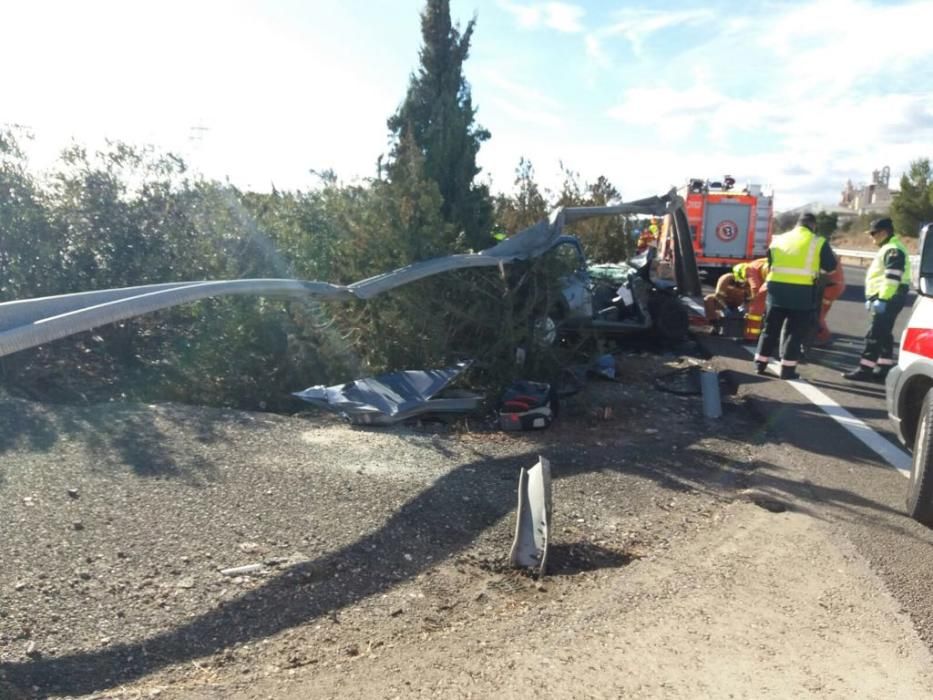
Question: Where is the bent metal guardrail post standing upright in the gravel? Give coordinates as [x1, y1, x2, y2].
[509, 457, 552, 576]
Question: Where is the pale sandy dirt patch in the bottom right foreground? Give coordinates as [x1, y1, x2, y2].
[197, 503, 931, 700]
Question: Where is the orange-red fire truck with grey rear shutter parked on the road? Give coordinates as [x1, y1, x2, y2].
[661, 175, 774, 280]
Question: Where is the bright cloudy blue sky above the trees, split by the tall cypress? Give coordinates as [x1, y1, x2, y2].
[0, 0, 933, 209]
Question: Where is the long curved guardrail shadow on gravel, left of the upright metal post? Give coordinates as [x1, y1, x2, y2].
[0, 448, 537, 695]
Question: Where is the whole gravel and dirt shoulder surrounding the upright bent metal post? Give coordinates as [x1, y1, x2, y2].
[0, 355, 931, 698]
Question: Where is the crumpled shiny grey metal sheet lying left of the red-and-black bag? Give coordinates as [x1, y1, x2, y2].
[293, 362, 483, 425]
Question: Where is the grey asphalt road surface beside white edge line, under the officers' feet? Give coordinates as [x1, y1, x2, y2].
[711, 267, 933, 645]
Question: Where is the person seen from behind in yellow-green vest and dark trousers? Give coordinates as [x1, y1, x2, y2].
[755, 212, 837, 379]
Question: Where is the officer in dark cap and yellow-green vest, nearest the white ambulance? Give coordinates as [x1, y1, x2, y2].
[842, 218, 911, 381]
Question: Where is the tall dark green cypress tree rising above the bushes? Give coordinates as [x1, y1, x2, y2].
[388, 0, 493, 249]
